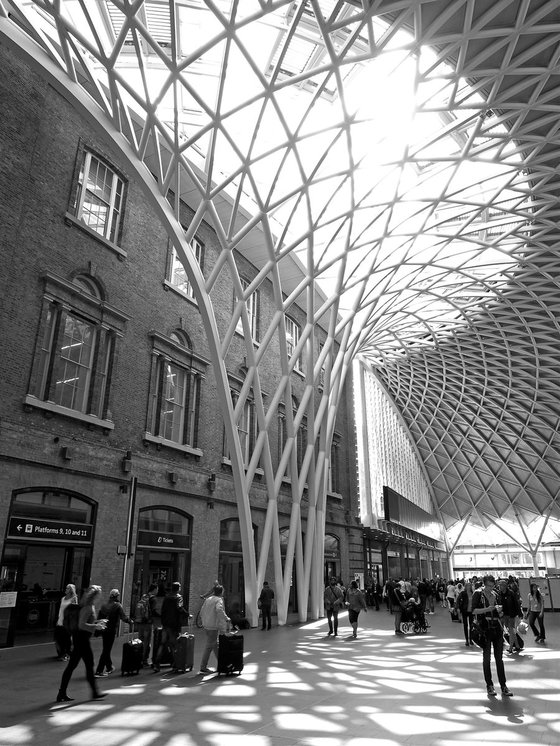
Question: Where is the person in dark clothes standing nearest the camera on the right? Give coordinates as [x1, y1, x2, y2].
[472, 575, 513, 697]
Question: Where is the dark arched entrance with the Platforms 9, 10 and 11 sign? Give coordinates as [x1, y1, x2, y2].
[0, 488, 96, 647]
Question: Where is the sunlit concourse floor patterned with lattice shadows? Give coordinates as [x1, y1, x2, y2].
[0, 607, 560, 746]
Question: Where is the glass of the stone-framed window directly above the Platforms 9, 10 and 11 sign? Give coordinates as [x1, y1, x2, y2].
[54, 314, 95, 412]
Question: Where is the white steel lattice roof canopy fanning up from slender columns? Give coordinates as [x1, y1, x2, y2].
[0, 0, 560, 619]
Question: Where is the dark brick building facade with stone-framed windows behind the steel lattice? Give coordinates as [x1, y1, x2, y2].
[0, 47, 363, 645]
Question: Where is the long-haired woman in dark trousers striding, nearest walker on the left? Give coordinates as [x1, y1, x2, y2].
[56, 585, 106, 702]
